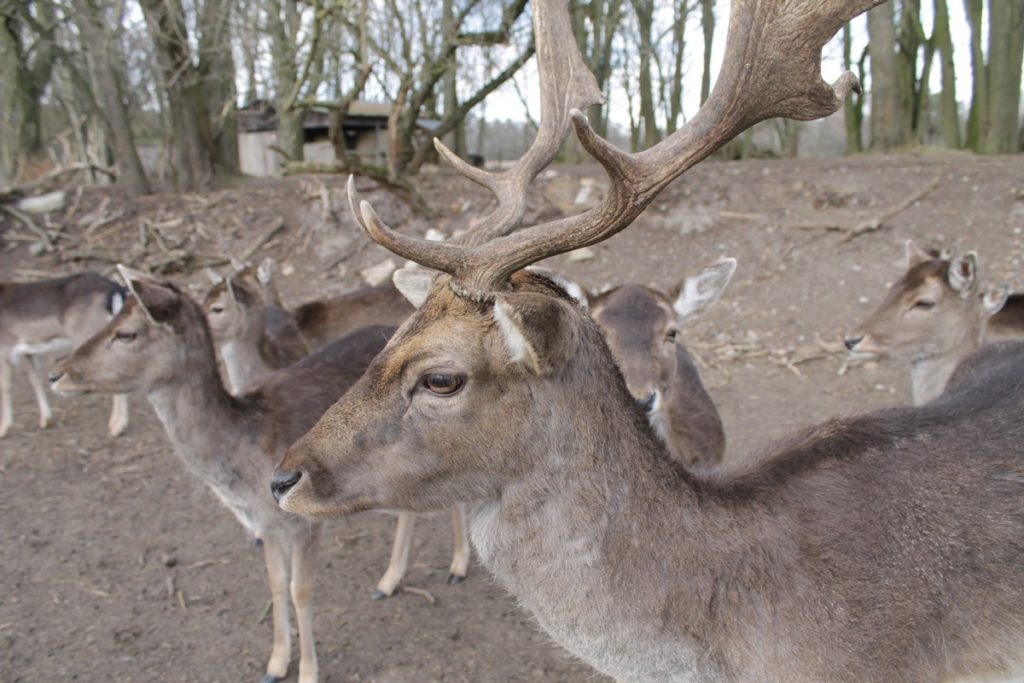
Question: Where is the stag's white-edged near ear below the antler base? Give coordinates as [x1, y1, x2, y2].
[494, 292, 577, 375]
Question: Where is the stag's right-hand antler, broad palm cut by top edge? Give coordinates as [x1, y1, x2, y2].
[444, 0, 885, 291]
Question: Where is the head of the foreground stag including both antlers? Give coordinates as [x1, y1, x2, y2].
[271, 0, 879, 516]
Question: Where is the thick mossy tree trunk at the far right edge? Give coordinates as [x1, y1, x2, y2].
[981, 0, 1024, 155]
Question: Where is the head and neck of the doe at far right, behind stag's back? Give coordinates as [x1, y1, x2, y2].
[844, 240, 1007, 405]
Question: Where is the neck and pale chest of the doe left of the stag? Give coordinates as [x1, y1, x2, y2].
[146, 340, 275, 532]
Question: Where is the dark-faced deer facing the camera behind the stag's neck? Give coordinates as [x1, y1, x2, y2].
[589, 258, 736, 465]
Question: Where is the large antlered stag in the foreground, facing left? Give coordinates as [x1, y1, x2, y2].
[269, 0, 1024, 683]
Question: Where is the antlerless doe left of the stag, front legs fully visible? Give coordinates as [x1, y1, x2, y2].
[52, 268, 393, 683]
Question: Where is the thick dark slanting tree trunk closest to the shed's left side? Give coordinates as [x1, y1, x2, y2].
[139, 0, 213, 189]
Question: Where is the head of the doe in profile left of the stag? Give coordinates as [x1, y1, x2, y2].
[51, 265, 213, 393]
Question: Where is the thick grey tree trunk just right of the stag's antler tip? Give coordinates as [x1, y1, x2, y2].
[867, 2, 907, 151]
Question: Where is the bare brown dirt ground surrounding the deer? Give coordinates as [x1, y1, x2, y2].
[0, 153, 1024, 683]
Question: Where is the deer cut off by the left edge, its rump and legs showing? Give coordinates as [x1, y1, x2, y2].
[0, 272, 128, 438]
